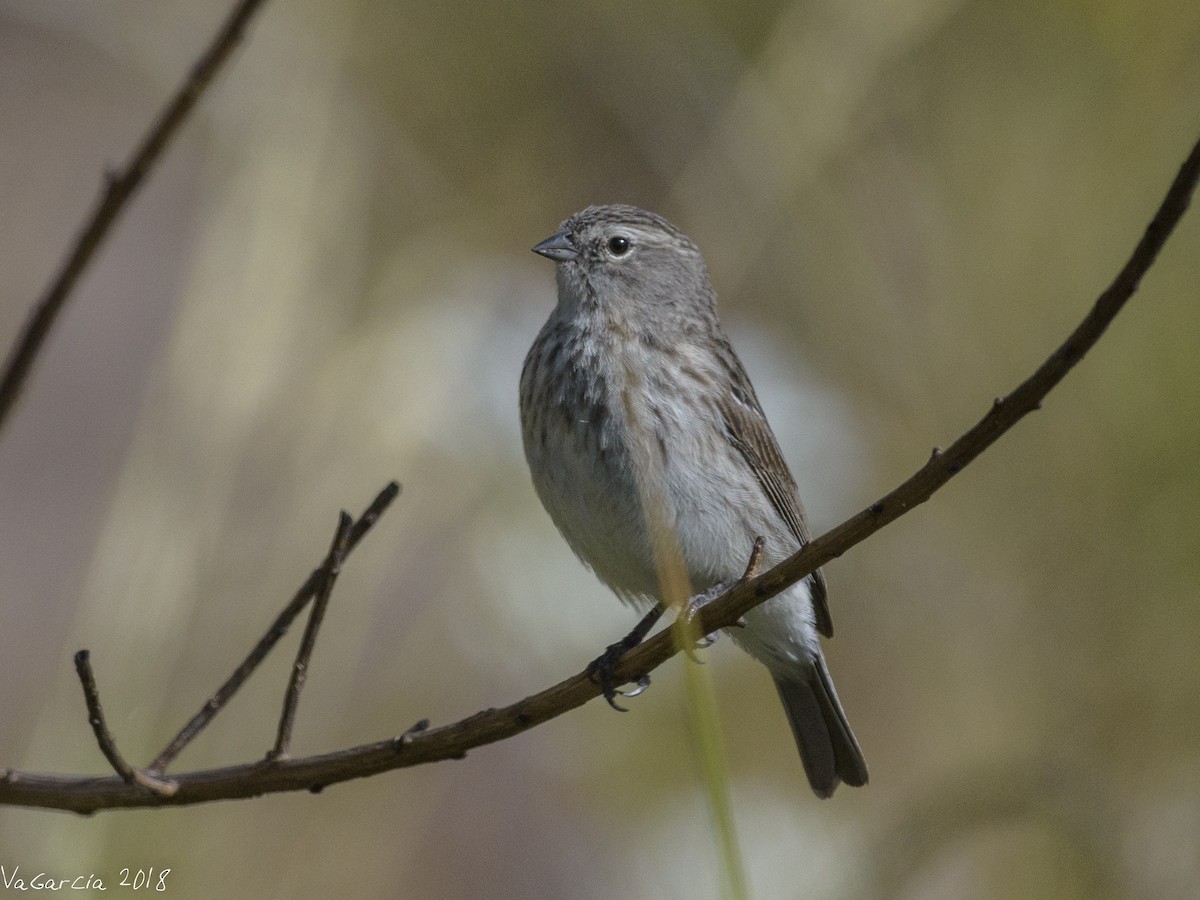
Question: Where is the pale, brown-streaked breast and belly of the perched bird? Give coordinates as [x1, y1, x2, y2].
[521, 320, 782, 596]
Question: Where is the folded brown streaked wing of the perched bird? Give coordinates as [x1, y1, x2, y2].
[718, 347, 833, 637]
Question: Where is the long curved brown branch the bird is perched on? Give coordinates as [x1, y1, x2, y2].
[0, 135, 1200, 812]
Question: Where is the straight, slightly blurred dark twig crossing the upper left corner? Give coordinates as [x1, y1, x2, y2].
[0, 0, 270, 439]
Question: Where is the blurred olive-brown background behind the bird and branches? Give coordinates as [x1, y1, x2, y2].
[0, 0, 1200, 900]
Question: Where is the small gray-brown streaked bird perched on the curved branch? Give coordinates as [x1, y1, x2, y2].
[521, 205, 868, 797]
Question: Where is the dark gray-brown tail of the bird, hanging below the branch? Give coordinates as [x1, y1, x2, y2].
[775, 654, 868, 798]
